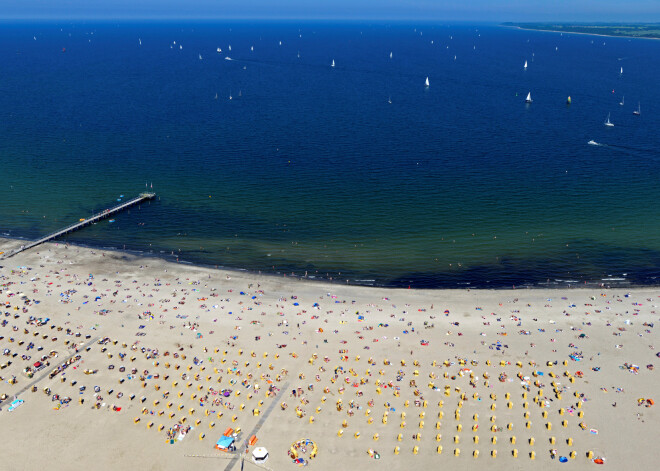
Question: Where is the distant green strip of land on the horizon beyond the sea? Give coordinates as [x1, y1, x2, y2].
[502, 22, 660, 39]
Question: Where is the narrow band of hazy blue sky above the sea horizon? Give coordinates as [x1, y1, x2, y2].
[0, 0, 660, 22]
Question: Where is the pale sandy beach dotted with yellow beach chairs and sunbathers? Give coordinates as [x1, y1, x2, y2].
[0, 240, 660, 471]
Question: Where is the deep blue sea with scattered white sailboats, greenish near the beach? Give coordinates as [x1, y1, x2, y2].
[0, 20, 660, 288]
